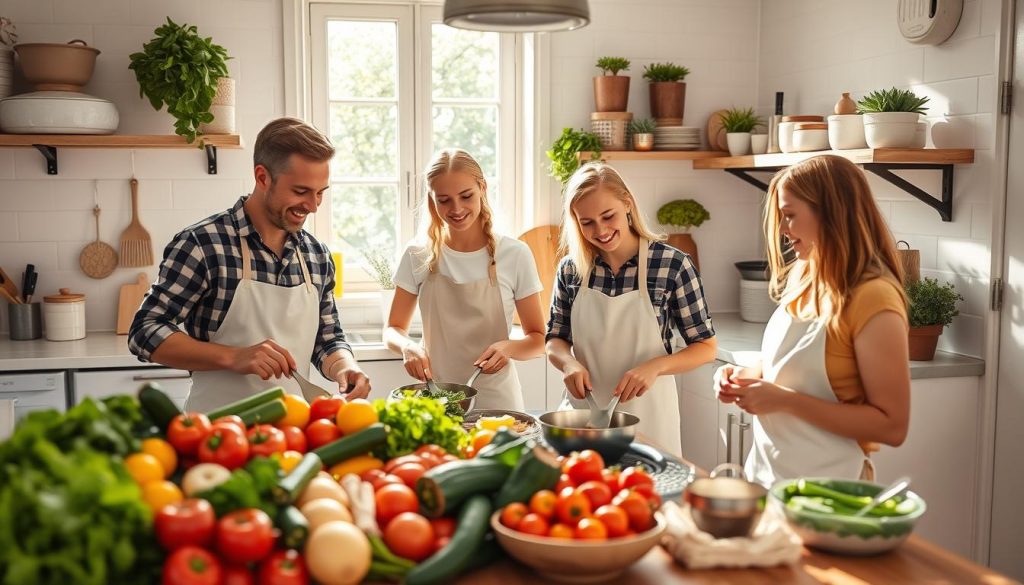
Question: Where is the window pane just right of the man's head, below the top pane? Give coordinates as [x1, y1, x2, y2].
[331, 103, 398, 178]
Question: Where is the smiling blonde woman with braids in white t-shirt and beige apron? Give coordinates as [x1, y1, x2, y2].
[384, 149, 544, 411]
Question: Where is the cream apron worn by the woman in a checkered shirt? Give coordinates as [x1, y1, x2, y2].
[559, 240, 682, 456]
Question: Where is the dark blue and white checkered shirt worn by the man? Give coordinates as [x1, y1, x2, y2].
[128, 196, 352, 371]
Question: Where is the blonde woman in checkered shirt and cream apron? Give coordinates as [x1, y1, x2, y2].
[547, 163, 716, 456]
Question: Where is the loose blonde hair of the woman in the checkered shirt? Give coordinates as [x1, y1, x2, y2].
[561, 162, 665, 278]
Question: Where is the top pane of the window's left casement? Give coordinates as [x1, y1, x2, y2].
[327, 20, 398, 99]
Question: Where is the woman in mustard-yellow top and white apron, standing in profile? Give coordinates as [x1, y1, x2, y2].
[715, 156, 910, 486]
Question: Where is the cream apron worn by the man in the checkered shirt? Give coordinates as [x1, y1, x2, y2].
[185, 237, 319, 412]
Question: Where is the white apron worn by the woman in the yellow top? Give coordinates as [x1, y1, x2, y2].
[745, 306, 870, 487]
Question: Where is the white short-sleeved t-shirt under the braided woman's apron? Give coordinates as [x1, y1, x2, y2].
[394, 236, 544, 330]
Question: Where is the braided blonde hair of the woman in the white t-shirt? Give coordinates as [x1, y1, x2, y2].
[415, 149, 497, 273]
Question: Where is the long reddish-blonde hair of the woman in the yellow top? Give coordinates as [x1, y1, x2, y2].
[765, 155, 906, 331]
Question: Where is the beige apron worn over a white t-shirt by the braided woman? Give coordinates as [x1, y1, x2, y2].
[419, 240, 525, 411]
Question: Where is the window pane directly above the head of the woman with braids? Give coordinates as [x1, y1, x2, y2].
[433, 106, 498, 176]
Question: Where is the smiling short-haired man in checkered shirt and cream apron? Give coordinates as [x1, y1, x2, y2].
[128, 118, 370, 411]
